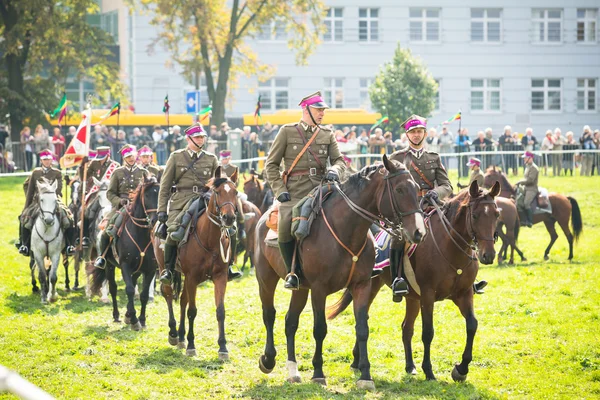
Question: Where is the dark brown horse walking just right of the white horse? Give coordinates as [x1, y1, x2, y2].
[91, 177, 159, 331]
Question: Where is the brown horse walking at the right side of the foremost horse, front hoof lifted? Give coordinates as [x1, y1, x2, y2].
[328, 181, 500, 381]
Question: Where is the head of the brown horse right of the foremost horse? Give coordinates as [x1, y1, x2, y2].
[467, 181, 500, 264]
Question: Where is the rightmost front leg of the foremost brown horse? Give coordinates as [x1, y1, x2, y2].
[352, 279, 375, 390]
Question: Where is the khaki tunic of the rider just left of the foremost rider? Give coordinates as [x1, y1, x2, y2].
[158, 149, 219, 227]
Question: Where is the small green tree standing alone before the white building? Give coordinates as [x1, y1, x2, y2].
[369, 44, 438, 131]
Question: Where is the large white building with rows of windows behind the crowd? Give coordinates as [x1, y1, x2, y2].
[96, 0, 600, 138]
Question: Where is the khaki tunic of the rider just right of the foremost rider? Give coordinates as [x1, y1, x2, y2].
[390, 149, 453, 200]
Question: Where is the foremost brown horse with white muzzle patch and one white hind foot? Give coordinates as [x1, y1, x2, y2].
[255, 155, 425, 389]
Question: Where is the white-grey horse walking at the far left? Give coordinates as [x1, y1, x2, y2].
[31, 180, 65, 304]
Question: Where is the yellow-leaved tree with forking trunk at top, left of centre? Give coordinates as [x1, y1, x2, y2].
[142, 0, 324, 124]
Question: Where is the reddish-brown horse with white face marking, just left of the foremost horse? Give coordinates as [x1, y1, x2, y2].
[154, 167, 237, 360]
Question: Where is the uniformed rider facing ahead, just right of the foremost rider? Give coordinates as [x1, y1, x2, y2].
[390, 115, 452, 302]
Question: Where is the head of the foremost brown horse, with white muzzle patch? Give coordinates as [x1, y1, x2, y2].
[378, 154, 427, 243]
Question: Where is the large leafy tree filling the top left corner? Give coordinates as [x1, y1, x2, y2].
[0, 0, 124, 142]
